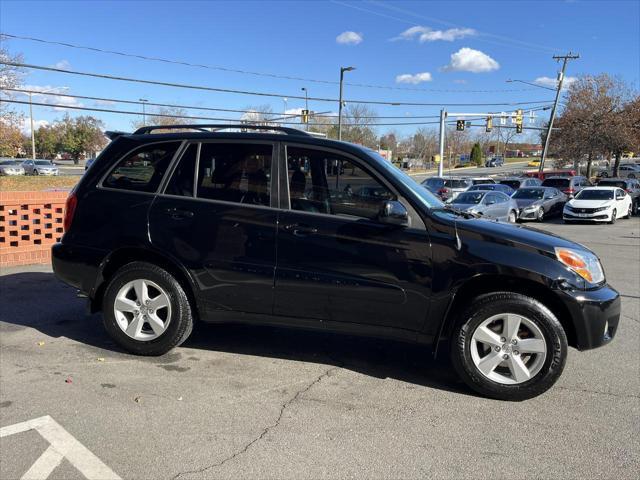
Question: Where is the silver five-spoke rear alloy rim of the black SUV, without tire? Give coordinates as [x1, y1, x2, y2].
[113, 279, 171, 341]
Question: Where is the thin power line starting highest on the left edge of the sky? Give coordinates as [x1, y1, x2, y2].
[0, 33, 533, 93]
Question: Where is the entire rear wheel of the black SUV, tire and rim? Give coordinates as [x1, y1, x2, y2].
[103, 262, 193, 356]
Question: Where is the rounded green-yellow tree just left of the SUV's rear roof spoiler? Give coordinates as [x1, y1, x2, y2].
[55, 115, 107, 164]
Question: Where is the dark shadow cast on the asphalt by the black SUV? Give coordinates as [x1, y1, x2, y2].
[0, 272, 474, 395]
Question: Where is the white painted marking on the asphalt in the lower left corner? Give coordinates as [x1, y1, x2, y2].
[0, 415, 121, 480]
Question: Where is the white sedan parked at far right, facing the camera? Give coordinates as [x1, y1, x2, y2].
[562, 187, 633, 223]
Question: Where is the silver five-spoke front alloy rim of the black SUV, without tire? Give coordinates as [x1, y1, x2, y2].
[470, 313, 547, 385]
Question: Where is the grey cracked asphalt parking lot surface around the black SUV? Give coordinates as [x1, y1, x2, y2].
[0, 217, 640, 479]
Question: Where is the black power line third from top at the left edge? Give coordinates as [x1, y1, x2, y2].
[5, 87, 547, 120]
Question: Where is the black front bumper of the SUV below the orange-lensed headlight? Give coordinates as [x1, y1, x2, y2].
[559, 285, 621, 350]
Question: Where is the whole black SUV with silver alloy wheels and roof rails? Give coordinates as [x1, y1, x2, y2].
[53, 125, 620, 400]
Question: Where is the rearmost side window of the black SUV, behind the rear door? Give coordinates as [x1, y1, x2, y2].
[102, 142, 181, 192]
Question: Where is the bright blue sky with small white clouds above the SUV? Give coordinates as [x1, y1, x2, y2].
[0, 0, 640, 134]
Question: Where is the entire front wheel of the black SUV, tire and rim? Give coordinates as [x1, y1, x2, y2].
[451, 292, 568, 401]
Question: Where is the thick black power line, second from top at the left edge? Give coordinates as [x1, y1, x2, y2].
[0, 61, 549, 107]
